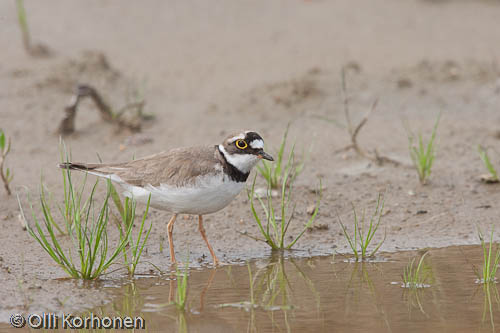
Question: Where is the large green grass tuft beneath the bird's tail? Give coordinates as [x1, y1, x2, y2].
[18, 170, 132, 280]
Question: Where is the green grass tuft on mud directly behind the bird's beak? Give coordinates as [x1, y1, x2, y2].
[257, 124, 305, 189]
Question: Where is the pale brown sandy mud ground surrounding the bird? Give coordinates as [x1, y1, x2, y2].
[0, 0, 500, 321]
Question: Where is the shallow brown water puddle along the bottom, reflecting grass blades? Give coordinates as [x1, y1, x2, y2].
[3, 246, 500, 332]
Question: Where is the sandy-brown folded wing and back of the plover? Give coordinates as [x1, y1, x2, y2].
[89, 147, 220, 186]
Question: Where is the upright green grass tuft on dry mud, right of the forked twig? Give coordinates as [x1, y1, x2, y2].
[408, 114, 441, 184]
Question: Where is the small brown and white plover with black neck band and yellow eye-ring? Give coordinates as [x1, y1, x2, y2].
[59, 131, 274, 266]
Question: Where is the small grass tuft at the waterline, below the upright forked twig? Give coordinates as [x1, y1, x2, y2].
[338, 194, 387, 261]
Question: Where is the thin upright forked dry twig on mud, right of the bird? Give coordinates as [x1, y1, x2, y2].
[336, 68, 401, 166]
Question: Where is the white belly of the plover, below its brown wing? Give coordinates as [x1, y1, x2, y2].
[122, 174, 245, 215]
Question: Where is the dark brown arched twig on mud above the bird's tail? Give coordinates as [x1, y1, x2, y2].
[58, 84, 145, 135]
